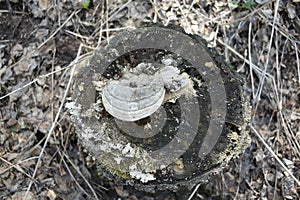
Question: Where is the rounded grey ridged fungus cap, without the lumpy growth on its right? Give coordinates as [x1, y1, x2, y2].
[102, 73, 165, 121]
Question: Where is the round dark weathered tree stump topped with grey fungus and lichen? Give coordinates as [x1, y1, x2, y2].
[68, 25, 250, 191]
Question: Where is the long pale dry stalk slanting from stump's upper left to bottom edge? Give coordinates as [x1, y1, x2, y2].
[24, 44, 82, 200]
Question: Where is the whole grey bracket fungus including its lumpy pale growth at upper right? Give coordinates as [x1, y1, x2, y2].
[102, 63, 188, 121]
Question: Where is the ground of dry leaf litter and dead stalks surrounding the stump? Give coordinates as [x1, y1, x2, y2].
[0, 0, 300, 200]
